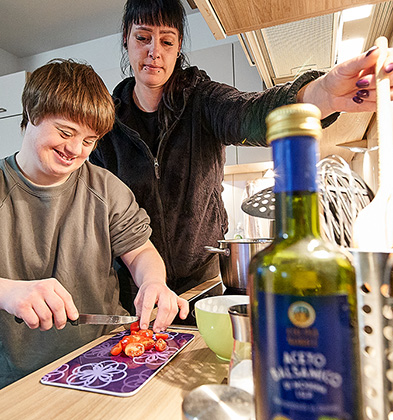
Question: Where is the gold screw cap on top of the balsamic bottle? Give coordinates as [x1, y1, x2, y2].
[266, 104, 322, 144]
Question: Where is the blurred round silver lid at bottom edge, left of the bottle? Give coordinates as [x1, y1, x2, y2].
[182, 384, 255, 420]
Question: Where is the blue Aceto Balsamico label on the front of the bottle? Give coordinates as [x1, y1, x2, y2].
[254, 292, 355, 420]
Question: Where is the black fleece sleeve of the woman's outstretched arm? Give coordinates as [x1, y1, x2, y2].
[201, 70, 339, 146]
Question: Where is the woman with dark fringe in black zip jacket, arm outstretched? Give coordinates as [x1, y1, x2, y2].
[91, 0, 393, 306]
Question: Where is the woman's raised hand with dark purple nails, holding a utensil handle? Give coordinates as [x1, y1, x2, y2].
[301, 47, 393, 118]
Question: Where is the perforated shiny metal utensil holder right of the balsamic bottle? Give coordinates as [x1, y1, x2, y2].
[351, 250, 393, 420]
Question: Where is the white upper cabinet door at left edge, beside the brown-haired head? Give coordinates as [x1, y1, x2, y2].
[0, 71, 26, 118]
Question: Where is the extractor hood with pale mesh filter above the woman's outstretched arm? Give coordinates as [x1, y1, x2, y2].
[238, 2, 393, 87]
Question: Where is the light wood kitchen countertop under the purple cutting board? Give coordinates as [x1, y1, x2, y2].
[0, 278, 228, 420]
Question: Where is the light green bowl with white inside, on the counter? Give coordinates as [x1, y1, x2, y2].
[195, 295, 250, 361]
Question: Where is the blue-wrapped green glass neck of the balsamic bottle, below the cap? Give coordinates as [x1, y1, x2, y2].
[272, 136, 320, 239]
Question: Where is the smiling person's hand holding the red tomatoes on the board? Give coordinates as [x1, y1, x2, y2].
[134, 282, 189, 332]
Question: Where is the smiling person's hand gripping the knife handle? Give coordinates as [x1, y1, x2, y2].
[0, 278, 78, 331]
